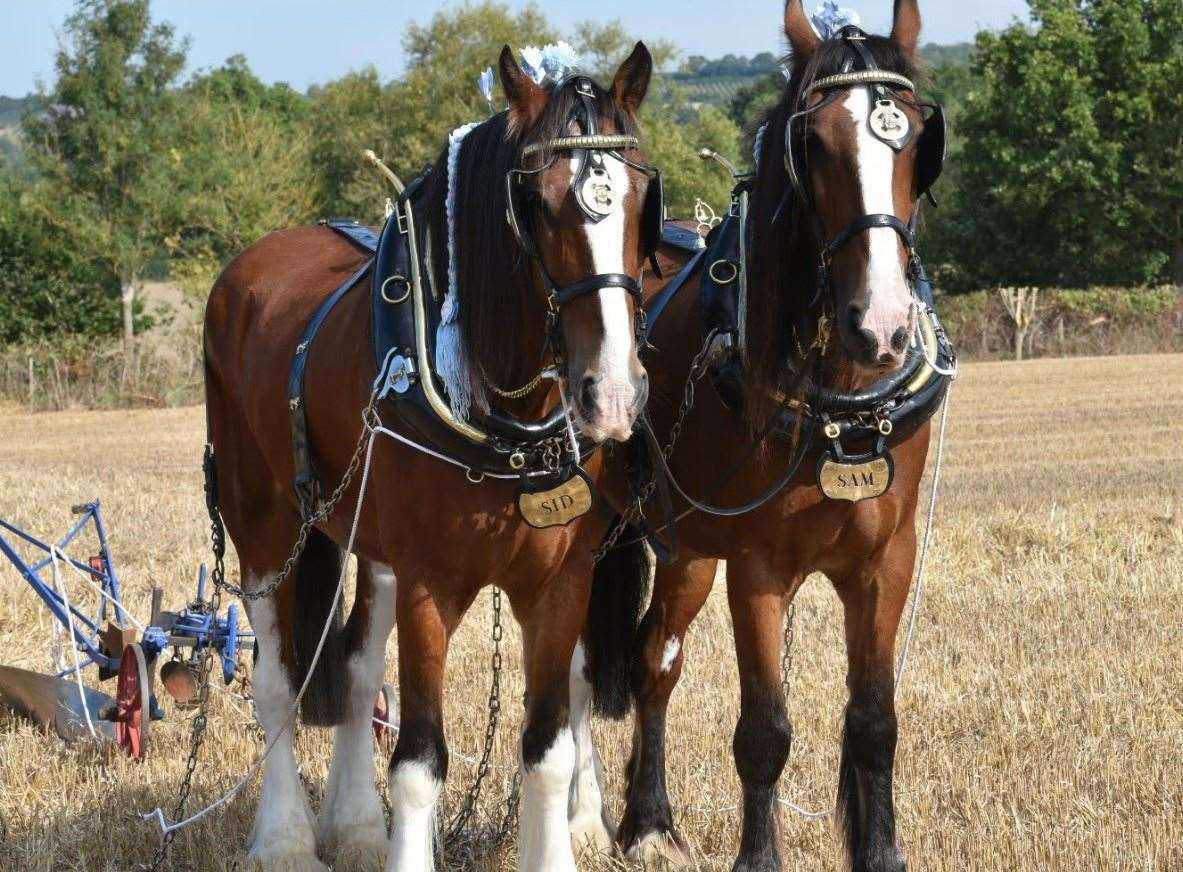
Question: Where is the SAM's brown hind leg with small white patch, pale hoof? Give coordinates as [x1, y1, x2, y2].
[619, 558, 718, 866]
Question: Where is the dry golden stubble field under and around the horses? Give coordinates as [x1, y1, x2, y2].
[0, 356, 1183, 872]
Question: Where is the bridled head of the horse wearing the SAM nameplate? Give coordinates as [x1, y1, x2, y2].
[782, 0, 944, 375]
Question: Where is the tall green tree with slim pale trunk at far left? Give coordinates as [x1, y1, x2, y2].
[24, 0, 187, 353]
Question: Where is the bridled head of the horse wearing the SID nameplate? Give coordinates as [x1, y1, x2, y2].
[499, 43, 664, 441]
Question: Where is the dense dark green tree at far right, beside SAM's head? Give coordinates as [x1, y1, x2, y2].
[940, 0, 1183, 288]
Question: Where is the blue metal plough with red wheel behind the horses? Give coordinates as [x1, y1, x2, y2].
[0, 500, 254, 758]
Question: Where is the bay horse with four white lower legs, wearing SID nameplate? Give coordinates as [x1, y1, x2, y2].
[205, 44, 653, 872]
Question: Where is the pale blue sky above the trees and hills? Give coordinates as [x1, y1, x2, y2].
[0, 0, 1027, 96]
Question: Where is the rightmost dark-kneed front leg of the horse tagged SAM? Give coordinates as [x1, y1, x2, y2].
[834, 530, 916, 872]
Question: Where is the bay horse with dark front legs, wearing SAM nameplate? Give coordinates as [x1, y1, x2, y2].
[573, 0, 944, 872]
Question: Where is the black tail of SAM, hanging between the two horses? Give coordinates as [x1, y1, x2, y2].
[583, 518, 649, 721]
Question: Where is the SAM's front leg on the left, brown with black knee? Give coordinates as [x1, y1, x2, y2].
[728, 563, 793, 872]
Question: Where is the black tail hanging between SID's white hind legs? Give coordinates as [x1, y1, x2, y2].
[291, 528, 349, 726]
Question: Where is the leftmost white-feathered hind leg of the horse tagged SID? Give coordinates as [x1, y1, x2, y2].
[243, 567, 328, 872]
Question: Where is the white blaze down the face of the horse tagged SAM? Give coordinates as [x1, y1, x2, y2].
[845, 86, 912, 350]
